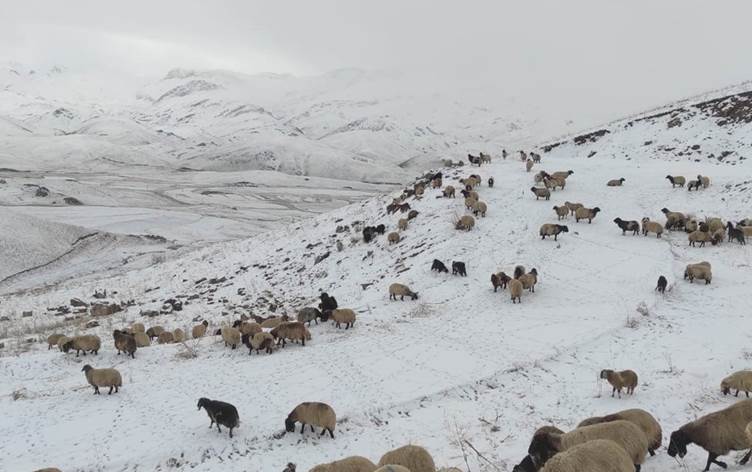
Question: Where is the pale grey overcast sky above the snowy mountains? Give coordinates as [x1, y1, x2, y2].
[0, 0, 752, 124]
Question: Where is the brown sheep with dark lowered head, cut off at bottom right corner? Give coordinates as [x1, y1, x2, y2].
[668, 399, 752, 472]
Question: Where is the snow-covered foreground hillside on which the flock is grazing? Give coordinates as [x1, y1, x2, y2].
[0, 122, 752, 472]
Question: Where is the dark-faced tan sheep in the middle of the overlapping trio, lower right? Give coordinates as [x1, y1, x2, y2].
[528, 420, 648, 472]
